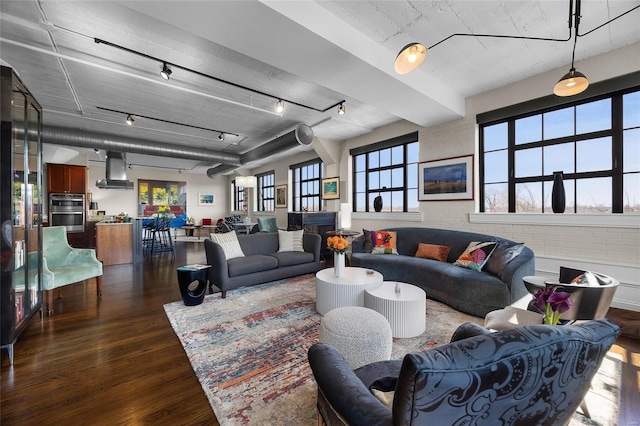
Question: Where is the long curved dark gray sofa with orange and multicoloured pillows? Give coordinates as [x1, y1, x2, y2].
[351, 227, 535, 317]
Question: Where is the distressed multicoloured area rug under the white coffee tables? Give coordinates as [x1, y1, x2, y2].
[164, 275, 620, 426]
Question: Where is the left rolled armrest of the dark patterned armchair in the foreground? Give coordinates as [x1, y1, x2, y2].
[308, 343, 393, 426]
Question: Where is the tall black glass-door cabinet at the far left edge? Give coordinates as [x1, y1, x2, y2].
[0, 67, 43, 364]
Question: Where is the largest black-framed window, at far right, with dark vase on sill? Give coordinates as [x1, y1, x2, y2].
[480, 88, 640, 213]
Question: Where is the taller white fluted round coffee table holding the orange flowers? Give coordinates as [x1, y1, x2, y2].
[316, 267, 383, 315]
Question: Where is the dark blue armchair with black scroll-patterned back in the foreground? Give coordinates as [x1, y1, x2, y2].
[308, 319, 620, 426]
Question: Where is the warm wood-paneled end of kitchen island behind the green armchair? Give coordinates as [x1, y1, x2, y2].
[96, 221, 133, 266]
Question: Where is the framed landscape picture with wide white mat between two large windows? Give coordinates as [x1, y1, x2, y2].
[418, 155, 473, 201]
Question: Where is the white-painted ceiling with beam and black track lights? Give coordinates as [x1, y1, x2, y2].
[0, 0, 640, 173]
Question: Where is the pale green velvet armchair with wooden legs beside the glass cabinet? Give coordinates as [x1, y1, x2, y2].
[42, 226, 102, 315]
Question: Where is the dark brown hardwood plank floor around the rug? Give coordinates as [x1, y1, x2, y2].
[0, 242, 640, 426]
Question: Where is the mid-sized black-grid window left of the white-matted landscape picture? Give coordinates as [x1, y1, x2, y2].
[351, 132, 419, 212]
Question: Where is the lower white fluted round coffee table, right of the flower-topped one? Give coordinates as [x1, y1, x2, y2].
[364, 281, 427, 337]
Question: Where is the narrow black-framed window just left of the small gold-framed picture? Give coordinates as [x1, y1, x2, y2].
[291, 159, 324, 212]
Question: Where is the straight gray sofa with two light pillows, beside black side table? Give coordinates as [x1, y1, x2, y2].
[204, 232, 322, 298]
